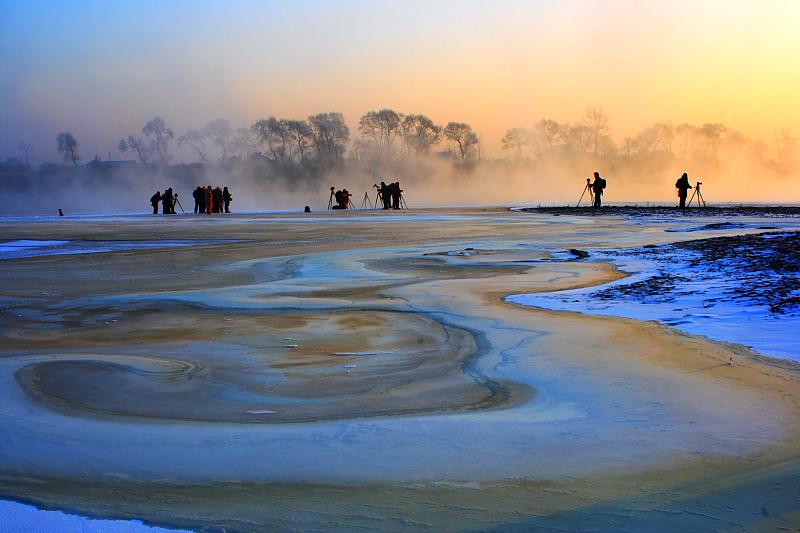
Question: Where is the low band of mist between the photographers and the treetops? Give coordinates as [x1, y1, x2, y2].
[0, 123, 800, 216]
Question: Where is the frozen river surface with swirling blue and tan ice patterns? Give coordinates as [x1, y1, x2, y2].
[0, 210, 800, 531]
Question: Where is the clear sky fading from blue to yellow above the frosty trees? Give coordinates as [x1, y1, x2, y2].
[0, 0, 800, 163]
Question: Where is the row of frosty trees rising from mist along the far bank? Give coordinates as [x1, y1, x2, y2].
[6, 106, 798, 174]
